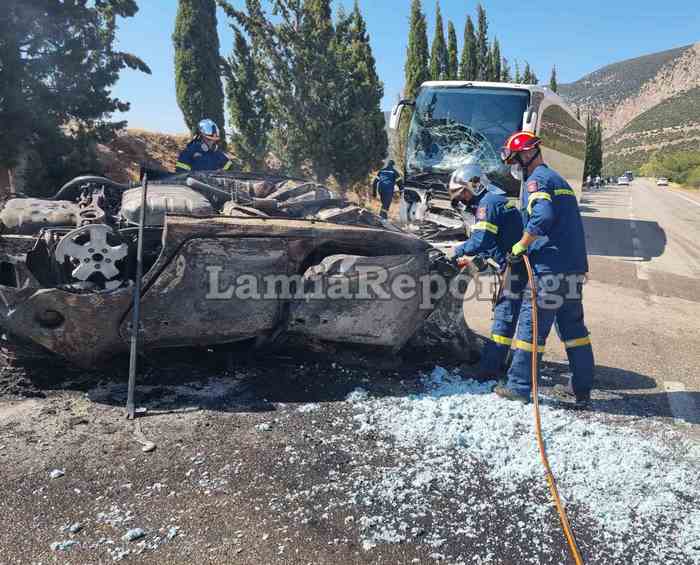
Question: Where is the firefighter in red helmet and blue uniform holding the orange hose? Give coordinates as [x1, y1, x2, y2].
[494, 132, 594, 408]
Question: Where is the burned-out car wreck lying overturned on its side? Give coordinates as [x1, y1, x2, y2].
[0, 172, 474, 368]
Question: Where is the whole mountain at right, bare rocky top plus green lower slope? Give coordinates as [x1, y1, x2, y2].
[559, 43, 700, 174]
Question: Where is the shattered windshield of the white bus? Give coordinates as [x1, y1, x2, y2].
[406, 87, 529, 194]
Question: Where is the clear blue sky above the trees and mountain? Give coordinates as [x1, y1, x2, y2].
[114, 0, 700, 133]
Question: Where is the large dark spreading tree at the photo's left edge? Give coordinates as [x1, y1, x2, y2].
[0, 0, 150, 195]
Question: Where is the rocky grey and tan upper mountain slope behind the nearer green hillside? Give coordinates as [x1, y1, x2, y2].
[560, 43, 700, 138]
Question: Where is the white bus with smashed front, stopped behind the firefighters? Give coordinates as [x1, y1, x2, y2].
[389, 81, 586, 237]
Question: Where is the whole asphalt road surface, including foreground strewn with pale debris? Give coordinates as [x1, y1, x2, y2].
[0, 180, 700, 565]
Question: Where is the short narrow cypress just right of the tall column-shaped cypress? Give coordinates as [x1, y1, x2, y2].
[226, 27, 270, 171]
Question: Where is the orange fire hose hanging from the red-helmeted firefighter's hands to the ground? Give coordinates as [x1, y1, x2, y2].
[523, 255, 583, 565]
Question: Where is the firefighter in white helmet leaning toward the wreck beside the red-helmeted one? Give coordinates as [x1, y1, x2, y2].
[448, 163, 526, 379]
